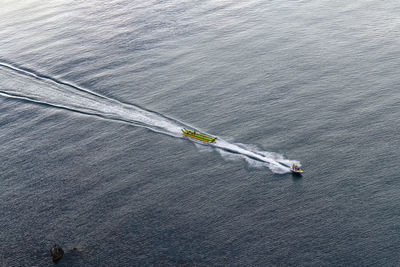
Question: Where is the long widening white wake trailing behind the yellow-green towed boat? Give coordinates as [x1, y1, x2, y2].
[0, 64, 181, 136]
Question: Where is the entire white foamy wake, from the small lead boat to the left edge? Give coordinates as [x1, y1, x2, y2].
[0, 63, 300, 173]
